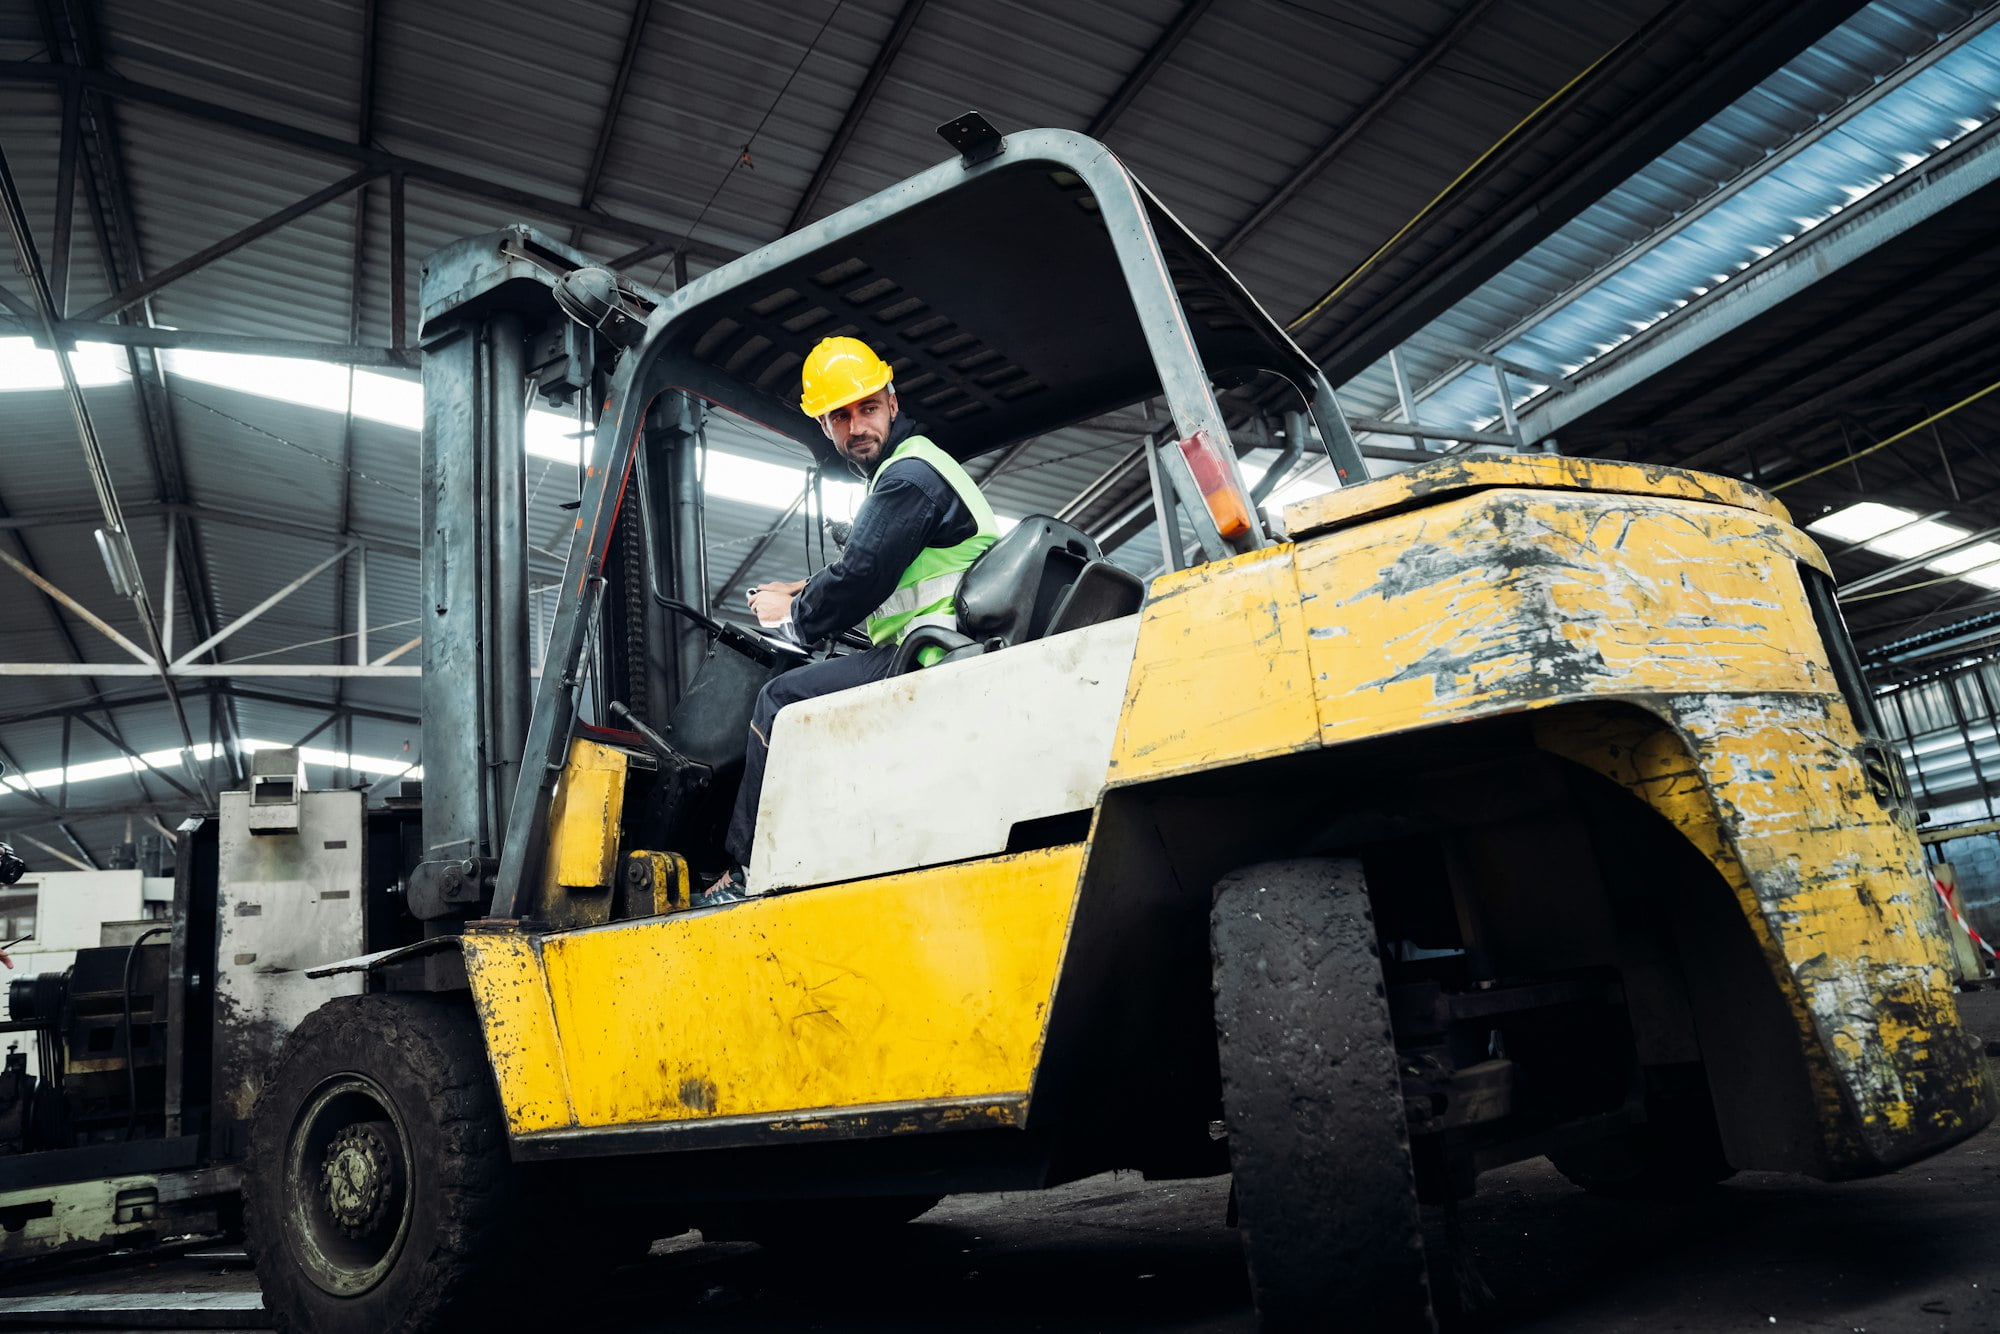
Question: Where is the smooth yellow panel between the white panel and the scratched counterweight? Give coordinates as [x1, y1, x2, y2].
[1110, 546, 1318, 784]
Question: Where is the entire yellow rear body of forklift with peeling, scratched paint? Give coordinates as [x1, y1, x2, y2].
[1114, 478, 1992, 1172]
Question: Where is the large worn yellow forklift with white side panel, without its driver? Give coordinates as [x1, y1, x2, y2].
[244, 118, 1994, 1334]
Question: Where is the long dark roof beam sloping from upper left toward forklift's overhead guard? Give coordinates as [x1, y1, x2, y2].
[0, 60, 738, 264]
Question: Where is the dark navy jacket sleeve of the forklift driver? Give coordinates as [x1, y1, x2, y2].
[792, 458, 976, 644]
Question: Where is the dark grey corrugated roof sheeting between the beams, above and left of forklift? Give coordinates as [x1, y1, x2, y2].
[0, 0, 1922, 860]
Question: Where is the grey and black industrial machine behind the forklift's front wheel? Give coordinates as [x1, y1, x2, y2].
[0, 750, 422, 1262]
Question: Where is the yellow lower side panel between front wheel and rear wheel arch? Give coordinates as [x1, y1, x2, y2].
[466, 844, 1084, 1134]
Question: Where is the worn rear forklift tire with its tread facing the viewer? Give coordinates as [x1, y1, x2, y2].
[1210, 858, 1436, 1334]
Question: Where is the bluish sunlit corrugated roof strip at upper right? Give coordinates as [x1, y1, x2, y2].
[1376, 0, 2000, 444]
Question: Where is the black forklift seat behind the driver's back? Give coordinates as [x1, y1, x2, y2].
[890, 514, 1146, 676]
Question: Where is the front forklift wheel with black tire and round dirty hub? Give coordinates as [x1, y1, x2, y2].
[244, 994, 518, 1334]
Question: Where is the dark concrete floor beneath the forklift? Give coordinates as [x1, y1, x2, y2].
[0, 990, 2000, 1334]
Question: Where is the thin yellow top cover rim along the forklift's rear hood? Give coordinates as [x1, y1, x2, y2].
[1284, 454, 1792, 540]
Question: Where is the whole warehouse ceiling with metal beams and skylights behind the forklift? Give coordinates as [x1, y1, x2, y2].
[0, 0, 2000, 864]
